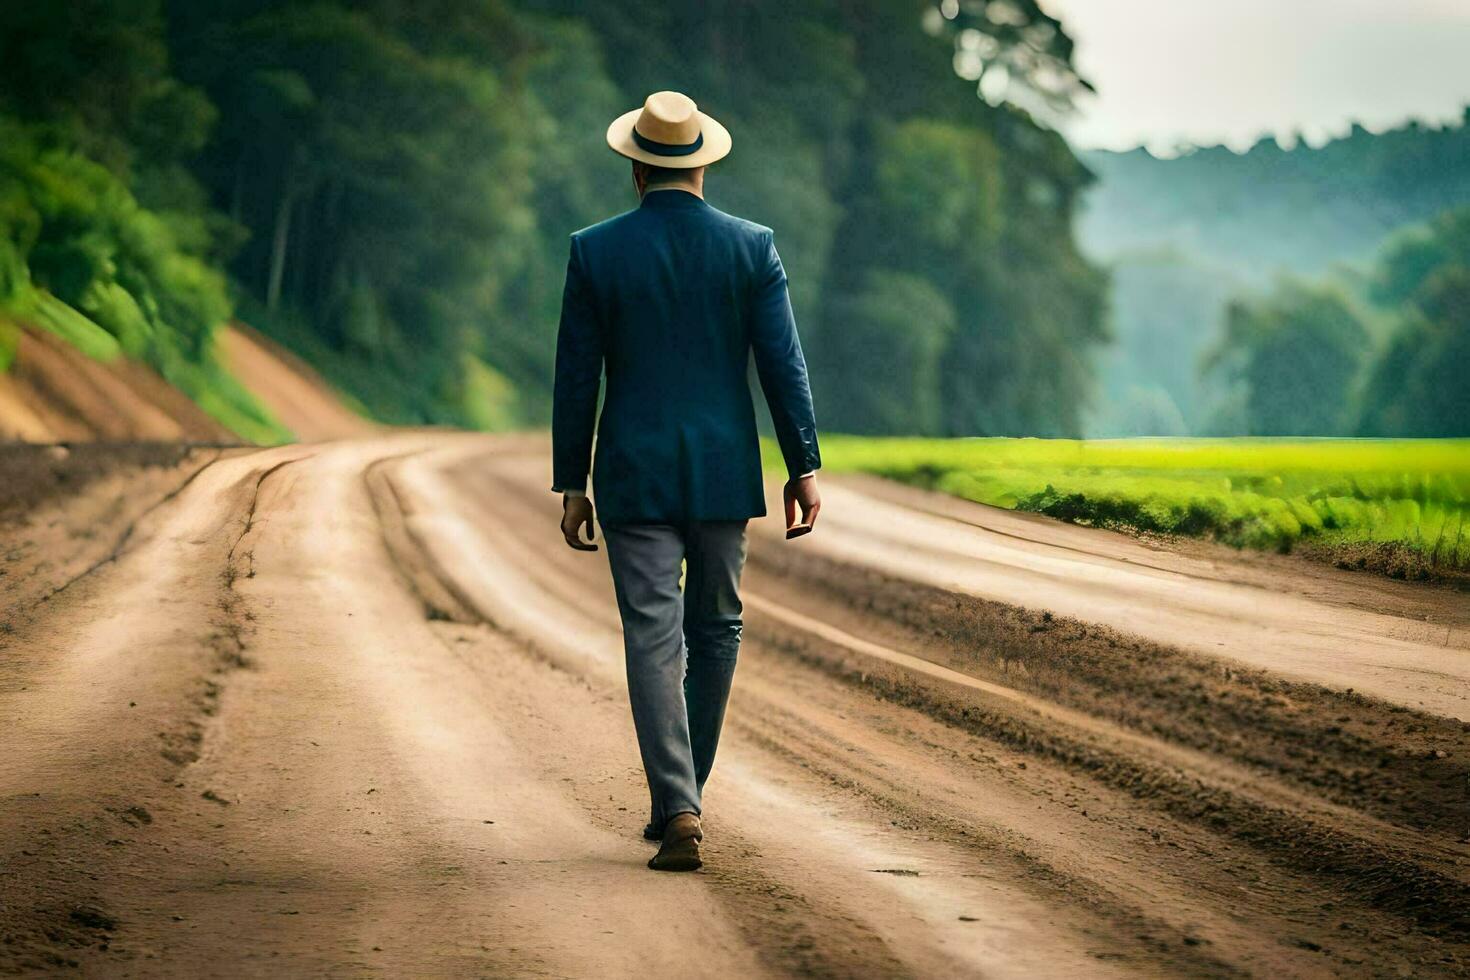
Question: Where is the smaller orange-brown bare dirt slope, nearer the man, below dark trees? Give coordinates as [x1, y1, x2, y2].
[219, 323, 375, 442]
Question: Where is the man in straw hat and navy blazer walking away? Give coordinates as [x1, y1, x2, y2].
[551, 91, 822, 871]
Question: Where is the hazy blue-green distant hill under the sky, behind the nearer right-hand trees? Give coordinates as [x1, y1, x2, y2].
[1078, 109, 1470, 436]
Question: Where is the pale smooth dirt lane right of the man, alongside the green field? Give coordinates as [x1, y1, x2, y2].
[816, 479, 1470, 721]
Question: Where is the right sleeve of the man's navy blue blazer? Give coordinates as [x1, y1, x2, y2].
[750, 231, 822, 479]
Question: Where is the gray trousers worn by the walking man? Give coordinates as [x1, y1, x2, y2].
[603, 520, 745, 826]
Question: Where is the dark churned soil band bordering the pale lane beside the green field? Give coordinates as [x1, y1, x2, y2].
[751, 548, 1470, 842]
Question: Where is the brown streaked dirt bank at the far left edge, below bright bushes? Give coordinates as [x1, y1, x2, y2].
[0, 329, 238, 442]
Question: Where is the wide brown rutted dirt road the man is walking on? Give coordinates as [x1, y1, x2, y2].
[0, 433, 1470, 977]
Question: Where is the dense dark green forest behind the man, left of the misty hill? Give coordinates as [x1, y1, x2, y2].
[0, 0, 1105, 433]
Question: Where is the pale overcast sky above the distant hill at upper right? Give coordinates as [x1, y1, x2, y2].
[1042, 0, 1470, 151]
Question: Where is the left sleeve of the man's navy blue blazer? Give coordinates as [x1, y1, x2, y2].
[551, 237, 604, 492]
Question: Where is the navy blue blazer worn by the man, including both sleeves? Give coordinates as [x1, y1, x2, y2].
[551, 190, 822, 525]
